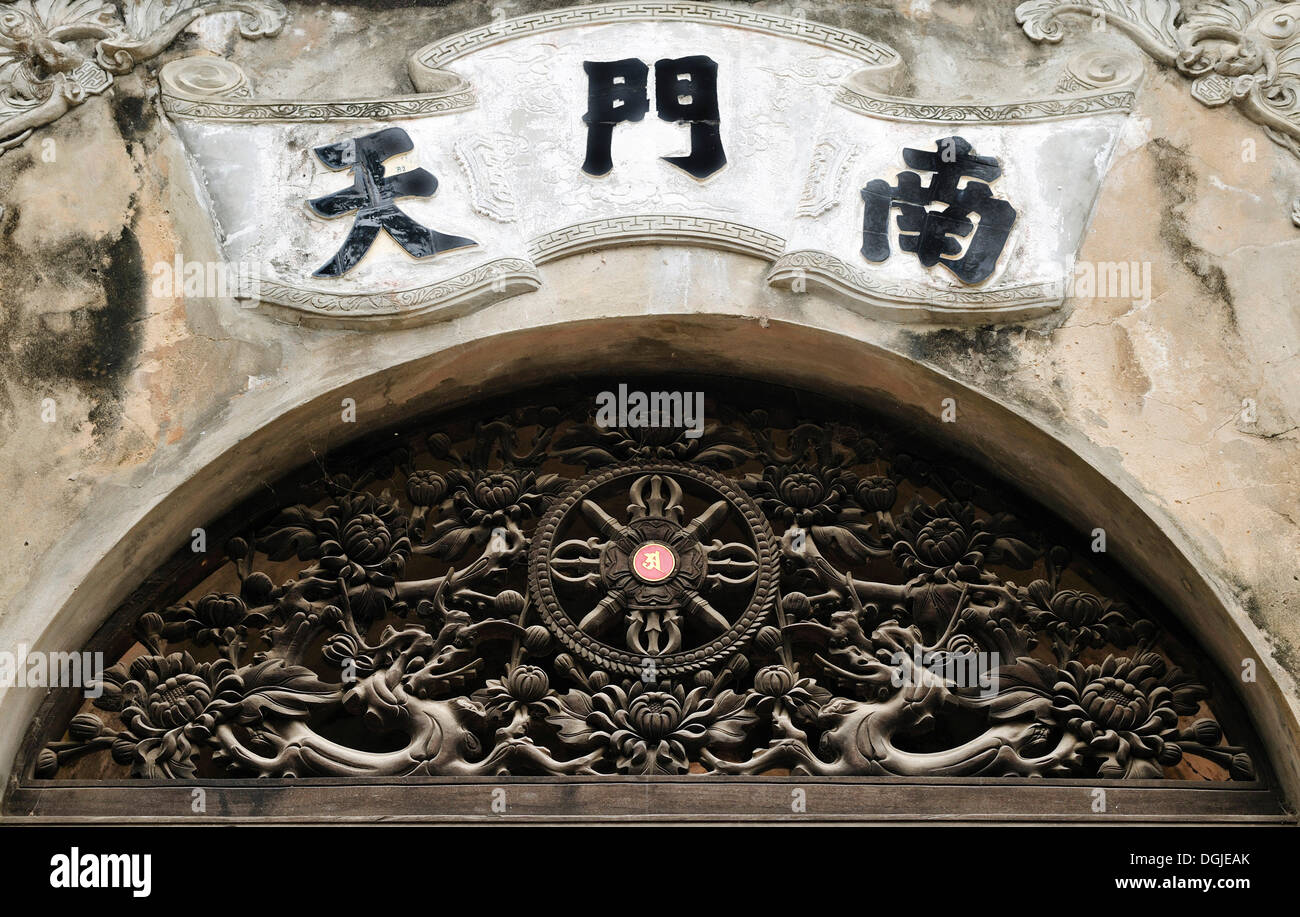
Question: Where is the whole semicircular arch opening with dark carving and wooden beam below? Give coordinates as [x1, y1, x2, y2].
[7, 373, 1281, 821]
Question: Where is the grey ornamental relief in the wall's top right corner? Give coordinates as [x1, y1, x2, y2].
[1015, 0, 1300, 226]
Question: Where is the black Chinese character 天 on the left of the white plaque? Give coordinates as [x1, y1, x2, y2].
[308, 127, 478, 277]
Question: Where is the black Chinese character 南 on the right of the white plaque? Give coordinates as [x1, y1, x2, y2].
[862, 137, 1015, 284]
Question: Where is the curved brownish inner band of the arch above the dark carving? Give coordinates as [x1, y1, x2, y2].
[5, 277, 1294, 816]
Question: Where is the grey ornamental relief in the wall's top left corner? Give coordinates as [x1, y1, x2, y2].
[0, 0, 287, 152]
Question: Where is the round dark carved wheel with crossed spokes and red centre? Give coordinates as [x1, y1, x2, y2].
[529, 462, 777, 679]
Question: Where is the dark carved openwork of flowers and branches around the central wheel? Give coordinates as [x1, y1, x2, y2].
[36, 392, 1253, 779]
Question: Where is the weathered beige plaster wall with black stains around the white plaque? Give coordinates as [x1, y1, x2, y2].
[0, 0, 1300, 796]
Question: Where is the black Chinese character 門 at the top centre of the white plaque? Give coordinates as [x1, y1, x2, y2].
[582, 55, 727, 179]
